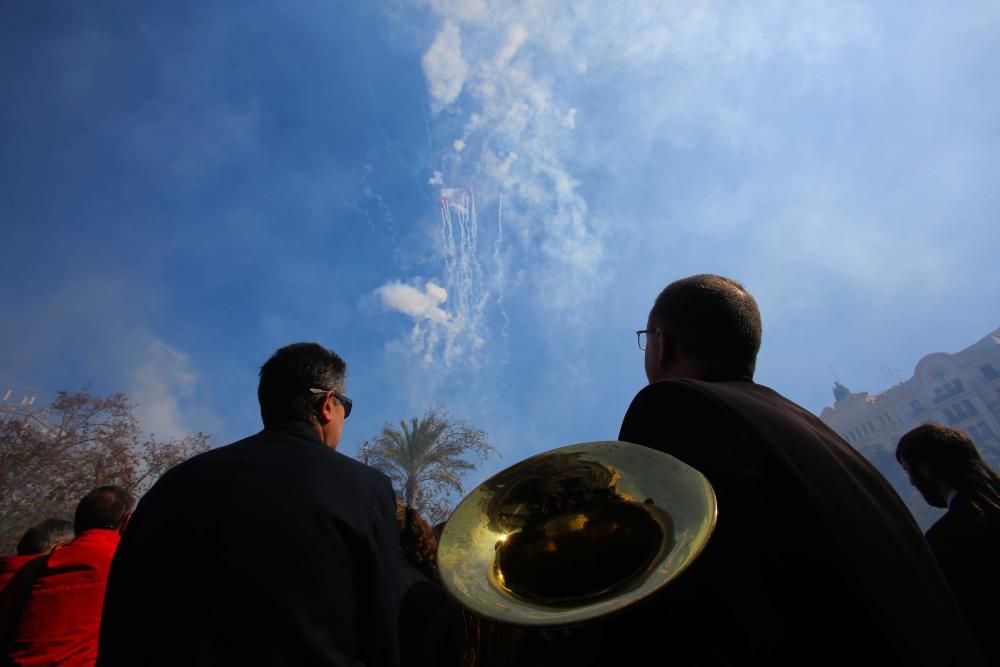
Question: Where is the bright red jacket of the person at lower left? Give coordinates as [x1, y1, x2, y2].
[0, 530, 119, 667]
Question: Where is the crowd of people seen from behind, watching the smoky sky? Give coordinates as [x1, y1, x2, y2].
[0, 275, 1000, 667]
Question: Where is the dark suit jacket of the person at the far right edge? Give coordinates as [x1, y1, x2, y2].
[927, 494, 1000, 665]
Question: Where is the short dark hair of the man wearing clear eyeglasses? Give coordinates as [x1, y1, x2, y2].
[649, 274, 761, 379]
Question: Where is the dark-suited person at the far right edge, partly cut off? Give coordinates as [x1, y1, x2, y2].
[896, 424, 1000, 664]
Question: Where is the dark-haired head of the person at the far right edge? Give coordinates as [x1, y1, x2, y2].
[896, 424, 1000, 510]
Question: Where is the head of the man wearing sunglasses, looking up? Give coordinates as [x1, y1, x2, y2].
[257, 343, 351, 448]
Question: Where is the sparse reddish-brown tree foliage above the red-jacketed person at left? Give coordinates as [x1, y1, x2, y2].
[0, 390, 209, 554]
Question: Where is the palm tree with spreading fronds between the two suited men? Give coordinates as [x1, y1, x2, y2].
[368, 408, 496, 523]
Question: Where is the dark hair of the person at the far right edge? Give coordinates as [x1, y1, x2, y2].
[896, 423, 1000, 511]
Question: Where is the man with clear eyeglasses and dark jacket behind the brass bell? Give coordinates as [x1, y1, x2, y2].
[605, 275, 982, 667]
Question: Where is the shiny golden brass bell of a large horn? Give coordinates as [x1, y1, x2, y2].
[438, 441, 717, 626]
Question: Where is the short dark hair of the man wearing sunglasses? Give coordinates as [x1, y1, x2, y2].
[257, 343, 347, 428]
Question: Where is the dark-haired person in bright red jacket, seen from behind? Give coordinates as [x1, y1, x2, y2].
[0, 486, 135, 667]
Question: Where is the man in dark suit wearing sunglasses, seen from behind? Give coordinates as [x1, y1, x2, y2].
[98, 343, 399, 667]
